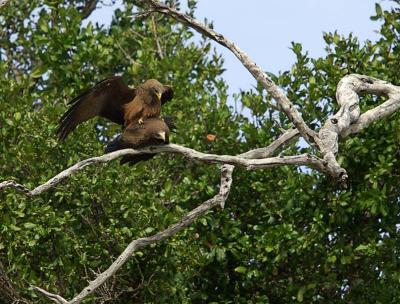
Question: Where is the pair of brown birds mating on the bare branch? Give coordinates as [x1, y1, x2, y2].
[57, 76, 175, 165]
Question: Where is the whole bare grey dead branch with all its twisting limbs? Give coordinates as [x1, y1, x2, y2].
[0, 0, 400, 304]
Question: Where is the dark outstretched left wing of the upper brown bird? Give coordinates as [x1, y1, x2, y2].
[57, 76, 135, 140]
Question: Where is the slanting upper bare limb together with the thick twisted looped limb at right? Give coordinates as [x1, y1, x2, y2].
[137, 0, 399, 185]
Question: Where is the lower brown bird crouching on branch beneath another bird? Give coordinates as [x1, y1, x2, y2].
[105, 117, 170, 166]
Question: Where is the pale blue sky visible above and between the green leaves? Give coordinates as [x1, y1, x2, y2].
[90, 0, 391, 93]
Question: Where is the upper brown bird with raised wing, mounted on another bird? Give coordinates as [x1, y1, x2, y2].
[57, 76, 174, 140]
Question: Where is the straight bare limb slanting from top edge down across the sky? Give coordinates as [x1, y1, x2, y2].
[141, 0, 317, 145]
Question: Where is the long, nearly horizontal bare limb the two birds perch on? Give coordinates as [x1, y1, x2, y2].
[0, 144, 326, 196]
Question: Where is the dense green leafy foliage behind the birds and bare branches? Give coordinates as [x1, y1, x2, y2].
[0, 0, 400, 303]
